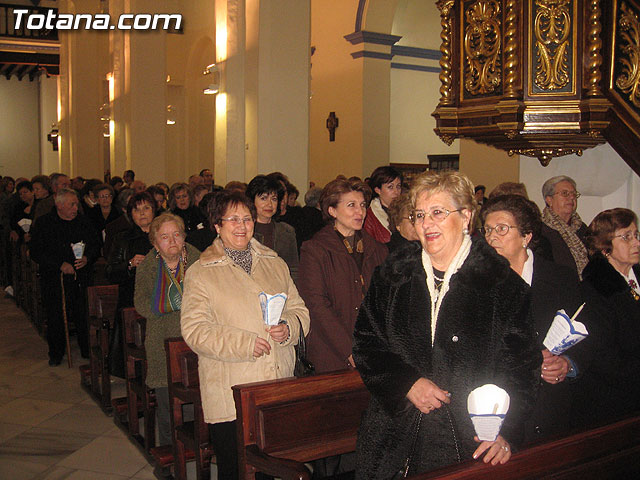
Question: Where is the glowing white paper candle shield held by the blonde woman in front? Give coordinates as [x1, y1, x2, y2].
[467, 383, 510, 442]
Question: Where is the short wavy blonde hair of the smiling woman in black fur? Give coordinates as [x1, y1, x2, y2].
[409, 170, 477, 225]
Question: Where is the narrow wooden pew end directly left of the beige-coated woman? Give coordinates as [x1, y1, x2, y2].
[164, 337, 213, 480]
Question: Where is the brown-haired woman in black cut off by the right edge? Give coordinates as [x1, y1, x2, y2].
[577, 208, 640, 423]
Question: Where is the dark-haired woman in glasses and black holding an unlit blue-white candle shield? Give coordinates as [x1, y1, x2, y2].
[480, 195, 591, 443]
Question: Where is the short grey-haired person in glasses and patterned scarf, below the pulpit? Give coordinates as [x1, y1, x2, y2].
[541, 175, 589, 275]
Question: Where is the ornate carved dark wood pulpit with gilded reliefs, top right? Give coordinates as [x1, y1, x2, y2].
[433, 0, 640, 173]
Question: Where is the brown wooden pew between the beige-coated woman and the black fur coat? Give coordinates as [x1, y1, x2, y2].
[233, 370, 369, 480]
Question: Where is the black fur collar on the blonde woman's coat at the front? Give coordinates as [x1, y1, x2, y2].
[380, 238, 515, 290]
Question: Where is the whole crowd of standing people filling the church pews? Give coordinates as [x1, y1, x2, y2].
[0, 166, 640, 479]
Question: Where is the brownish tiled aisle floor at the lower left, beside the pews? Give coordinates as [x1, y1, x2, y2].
[0, 297, 205, 480]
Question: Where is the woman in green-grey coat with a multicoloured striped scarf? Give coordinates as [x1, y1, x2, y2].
[134, 213, 200, 445]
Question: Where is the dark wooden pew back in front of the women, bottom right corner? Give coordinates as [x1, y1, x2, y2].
[410, 417, 640, 480]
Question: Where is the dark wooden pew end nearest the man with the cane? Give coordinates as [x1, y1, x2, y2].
[80, 285, 118, 415]
